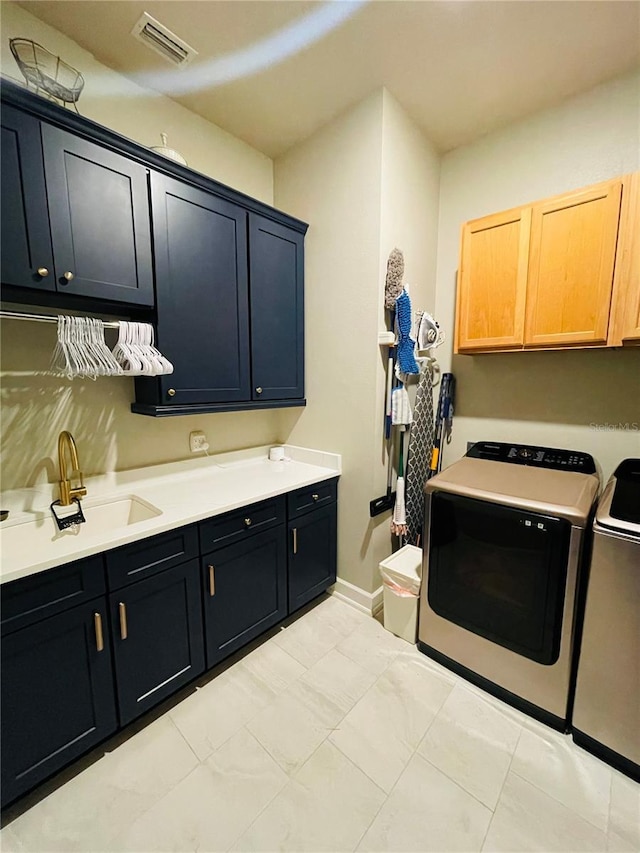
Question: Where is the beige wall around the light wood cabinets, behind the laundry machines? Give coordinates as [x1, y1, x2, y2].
[436, 74, 640, 477]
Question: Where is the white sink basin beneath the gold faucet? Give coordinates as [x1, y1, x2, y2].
[0, 495, 162, 561]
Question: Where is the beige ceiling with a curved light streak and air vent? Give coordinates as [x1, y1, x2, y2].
[13, 0, 640, 157]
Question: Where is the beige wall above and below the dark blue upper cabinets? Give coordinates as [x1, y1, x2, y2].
[0, 2, 284, 489]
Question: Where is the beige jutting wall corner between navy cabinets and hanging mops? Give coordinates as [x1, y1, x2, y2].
[275, 86, 439, 591]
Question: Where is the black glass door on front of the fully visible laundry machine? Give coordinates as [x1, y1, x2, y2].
[427, 492, 571, 664]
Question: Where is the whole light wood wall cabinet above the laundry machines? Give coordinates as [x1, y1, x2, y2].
[455, 174, 640, 353]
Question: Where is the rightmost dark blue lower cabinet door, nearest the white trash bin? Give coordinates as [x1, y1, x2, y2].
[289, 504, 337, 613]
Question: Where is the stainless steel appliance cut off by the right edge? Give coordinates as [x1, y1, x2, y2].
[573, 459, 640, 781]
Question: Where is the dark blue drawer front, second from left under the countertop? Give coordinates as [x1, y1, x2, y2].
[107, 525, 198, 589]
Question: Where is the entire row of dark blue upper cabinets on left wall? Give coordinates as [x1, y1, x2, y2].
[0, 81, 307, 417]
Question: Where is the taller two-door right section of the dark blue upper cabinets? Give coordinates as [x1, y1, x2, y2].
[132, 178, 306, 416]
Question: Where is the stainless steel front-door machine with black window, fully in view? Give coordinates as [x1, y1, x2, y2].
[418, 442, 599, 730]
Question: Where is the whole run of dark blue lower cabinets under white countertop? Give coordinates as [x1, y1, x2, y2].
[0, 484, 337, 807]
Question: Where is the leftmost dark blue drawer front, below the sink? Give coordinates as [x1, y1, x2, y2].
[1, 554, 105, 635]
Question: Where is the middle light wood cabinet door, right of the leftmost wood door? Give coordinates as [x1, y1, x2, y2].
[525, 180, 622, 347]
